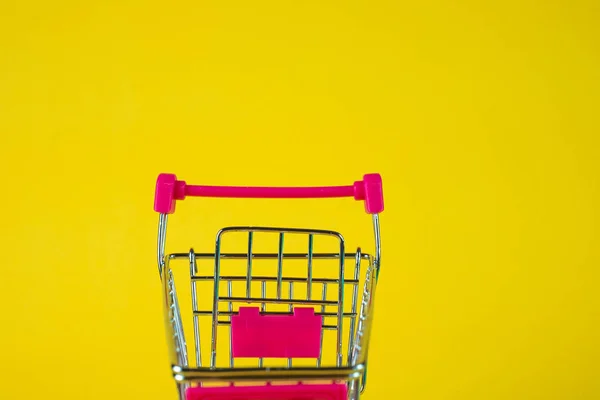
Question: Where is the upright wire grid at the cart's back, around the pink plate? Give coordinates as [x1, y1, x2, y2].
[170, 227, 370, 367]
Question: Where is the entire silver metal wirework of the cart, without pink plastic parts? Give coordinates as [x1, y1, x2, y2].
[158, 215, 381, 400]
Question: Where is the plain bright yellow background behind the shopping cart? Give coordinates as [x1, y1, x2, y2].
[0, 0, 600, 400]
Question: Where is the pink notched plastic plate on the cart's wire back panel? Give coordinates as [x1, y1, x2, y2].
[231, 307, 323, 358]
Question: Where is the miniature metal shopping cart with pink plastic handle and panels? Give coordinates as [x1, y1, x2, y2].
[154, 174, 383, 400]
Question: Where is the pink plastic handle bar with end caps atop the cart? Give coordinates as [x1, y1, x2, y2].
[154, 174, 383, 214]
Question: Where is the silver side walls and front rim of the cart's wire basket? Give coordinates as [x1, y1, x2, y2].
[158, 214, 381, 400]
